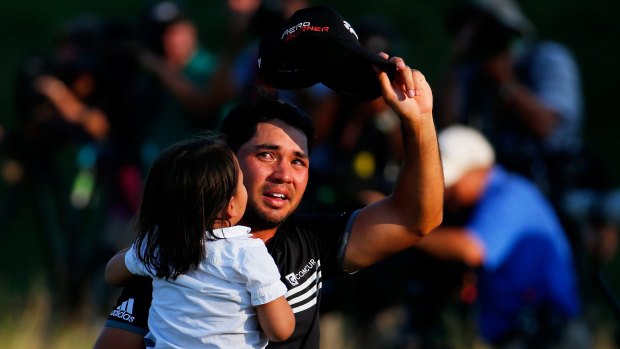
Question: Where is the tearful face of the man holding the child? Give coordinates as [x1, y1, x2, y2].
[237, 120, 309, 229]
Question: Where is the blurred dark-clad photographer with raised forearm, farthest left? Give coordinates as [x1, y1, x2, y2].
[0, 15, 141, 312]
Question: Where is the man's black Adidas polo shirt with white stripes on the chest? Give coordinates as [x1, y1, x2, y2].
[105, 214, 353, 349]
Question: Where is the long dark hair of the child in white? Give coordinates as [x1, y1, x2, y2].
[136, 137, 239, 279]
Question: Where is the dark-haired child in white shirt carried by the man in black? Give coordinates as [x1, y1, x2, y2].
[105, 139, 295, 348]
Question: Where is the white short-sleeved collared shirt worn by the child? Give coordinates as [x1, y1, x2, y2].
[125, 226, 286, 348]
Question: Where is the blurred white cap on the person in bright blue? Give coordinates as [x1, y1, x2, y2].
[438, 125, 495, 187]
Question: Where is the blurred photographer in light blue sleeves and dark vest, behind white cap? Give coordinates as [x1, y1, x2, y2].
[438, 0, 583, 203]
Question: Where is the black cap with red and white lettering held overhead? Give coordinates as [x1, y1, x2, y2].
[258, 6, 396, 100]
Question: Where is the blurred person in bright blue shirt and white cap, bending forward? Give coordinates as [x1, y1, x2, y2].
[417, 125, 588, 348]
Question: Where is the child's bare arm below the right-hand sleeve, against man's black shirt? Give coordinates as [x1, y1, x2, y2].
[256, 296, 295, 342]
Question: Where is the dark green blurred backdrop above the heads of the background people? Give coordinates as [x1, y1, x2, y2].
[0, 0, 620, 177]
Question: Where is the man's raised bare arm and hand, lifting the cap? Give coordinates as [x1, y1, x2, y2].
[344, 56, 444, 272]
